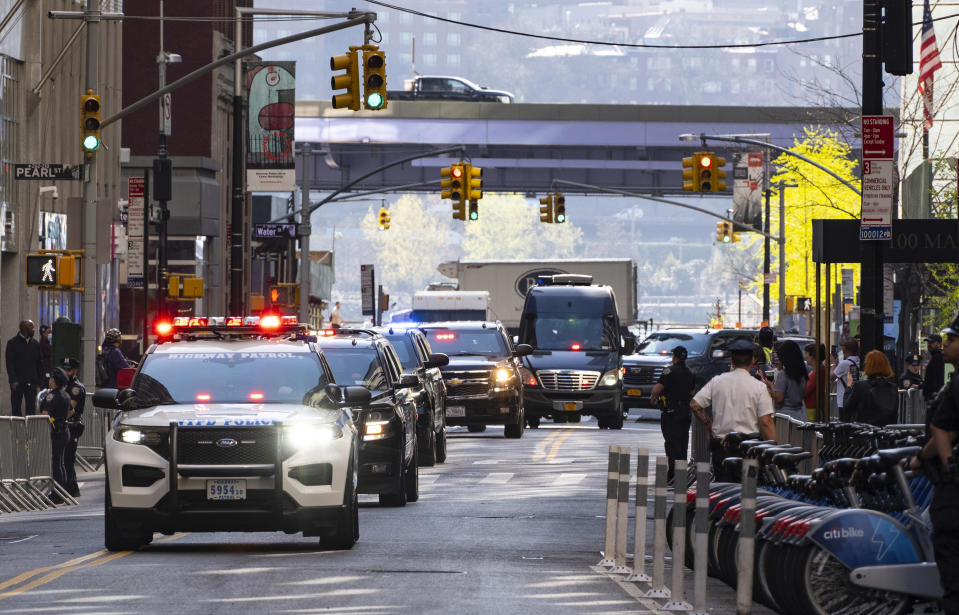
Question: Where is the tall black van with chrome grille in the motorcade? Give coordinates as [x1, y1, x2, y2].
[519, 274, 634, 429]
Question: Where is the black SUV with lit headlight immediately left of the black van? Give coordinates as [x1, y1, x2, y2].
[421, 321, 533, 438]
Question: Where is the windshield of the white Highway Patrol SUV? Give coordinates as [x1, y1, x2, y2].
[133, 351, 329, 407]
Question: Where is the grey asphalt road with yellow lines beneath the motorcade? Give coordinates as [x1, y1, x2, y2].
[0, 421, 769, 615]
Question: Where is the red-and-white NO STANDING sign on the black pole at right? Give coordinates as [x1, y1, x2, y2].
[859, 115, 895, 241]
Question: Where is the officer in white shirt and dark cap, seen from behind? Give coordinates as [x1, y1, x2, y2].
[689, 339, 776, 477]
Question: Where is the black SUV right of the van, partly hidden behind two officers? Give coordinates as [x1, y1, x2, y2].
[623, 327, 759, 408]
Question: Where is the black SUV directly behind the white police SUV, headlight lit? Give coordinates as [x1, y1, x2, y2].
[317, 328, 419, 506]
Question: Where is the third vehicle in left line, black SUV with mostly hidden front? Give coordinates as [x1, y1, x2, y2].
[374, 327, 450, 466]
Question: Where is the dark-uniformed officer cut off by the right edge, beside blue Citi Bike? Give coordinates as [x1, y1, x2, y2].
[911, 313, 959, 615]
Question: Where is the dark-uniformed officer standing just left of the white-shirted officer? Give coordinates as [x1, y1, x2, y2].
[649, 346, 696, 484]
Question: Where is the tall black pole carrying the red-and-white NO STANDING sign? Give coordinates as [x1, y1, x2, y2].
[864, 0, 884, 355]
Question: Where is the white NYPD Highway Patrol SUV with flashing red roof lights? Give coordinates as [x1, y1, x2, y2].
[92, 315, 370, 551]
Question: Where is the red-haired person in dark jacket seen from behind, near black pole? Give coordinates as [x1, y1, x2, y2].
[843, 350, 899, 427]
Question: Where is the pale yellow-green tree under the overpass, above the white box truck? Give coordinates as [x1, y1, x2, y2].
[463, 194, 583, 260]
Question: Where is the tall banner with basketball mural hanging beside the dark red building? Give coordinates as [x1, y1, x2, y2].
[245, 62, 296, 192]
